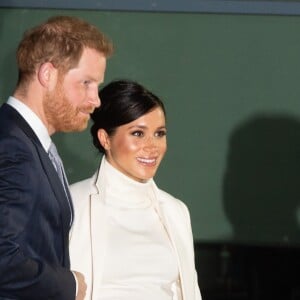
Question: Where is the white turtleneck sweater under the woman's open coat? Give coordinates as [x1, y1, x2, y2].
[85, 158, 181, 300]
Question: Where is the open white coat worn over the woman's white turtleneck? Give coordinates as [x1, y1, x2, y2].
[70, 159, 201, 300]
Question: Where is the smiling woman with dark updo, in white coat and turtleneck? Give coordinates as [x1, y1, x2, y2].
[70, 80, 201, 300]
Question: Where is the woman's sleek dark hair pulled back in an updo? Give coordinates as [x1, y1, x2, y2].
[91, 80, 166, 153]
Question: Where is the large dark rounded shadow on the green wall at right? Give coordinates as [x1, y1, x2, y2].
[223, 115, 300, 245]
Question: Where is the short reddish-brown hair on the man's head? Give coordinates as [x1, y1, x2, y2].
[17, 16, 113, 86]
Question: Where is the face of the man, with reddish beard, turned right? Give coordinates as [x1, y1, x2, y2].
[44, 48, 106, 132]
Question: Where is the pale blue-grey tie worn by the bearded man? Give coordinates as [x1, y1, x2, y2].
[48, 142, 73, 224]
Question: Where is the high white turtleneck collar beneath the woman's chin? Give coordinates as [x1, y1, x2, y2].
[97, 156, 156, 209]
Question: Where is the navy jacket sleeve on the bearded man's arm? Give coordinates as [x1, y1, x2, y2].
[0, 137, 76, 300]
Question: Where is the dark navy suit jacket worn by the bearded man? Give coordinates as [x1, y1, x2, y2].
[0, 104, 76, 300]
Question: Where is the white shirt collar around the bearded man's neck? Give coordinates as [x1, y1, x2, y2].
[7, 96, 51, 152]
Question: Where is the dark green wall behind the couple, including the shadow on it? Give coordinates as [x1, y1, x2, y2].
[0, 9, 300, 244]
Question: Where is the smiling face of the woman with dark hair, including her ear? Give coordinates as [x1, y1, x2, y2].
[98, 107, 167, 182]
